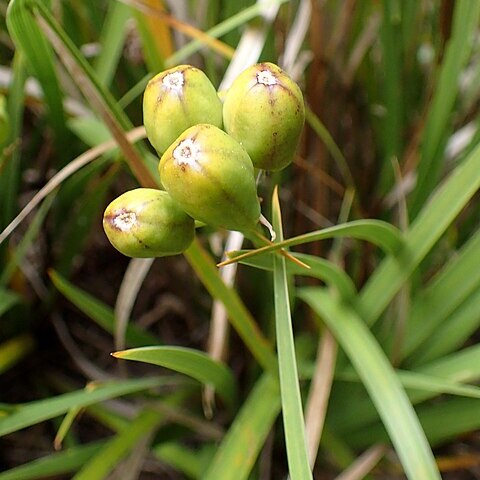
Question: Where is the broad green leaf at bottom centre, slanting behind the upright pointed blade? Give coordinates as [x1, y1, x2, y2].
[202, 373, 282, 480]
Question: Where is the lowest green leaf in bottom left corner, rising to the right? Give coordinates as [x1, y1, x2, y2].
[0, 441, 104, 480]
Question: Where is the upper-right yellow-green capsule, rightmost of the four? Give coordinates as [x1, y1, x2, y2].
[223, 63, 305, 170]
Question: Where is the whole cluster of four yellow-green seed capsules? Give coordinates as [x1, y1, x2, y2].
[103, 63, 305, 257]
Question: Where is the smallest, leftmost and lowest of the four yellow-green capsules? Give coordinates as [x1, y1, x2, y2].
[103, 188, 195, 258]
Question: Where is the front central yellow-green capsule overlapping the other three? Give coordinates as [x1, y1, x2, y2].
[158, 124, 260, 231]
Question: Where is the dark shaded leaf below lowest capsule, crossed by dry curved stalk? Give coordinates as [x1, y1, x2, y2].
[49, 270, 158, 346]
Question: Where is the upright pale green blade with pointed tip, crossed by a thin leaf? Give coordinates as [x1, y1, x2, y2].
[272, 188, 313, 480]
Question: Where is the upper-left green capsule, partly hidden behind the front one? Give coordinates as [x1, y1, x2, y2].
[143, 65, 222, 154]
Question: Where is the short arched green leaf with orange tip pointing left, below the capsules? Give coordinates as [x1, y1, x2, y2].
[112, 347, 237, 406]
